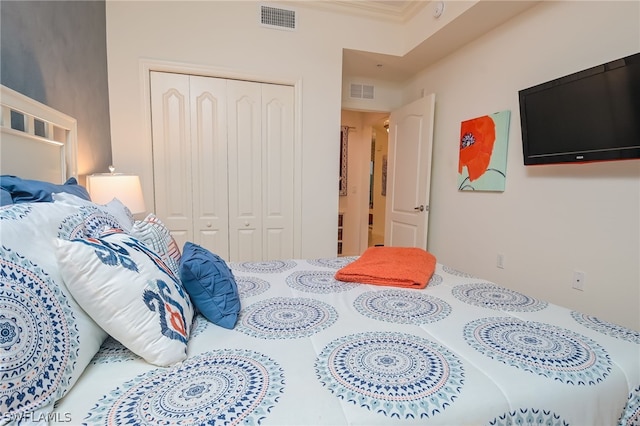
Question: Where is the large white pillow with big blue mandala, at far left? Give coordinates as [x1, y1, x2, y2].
[0, 202, 107, 423]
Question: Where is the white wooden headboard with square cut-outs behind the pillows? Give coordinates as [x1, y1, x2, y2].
[0, 85, 78, 184]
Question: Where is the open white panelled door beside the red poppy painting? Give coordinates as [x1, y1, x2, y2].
[384, 94, 435, 249]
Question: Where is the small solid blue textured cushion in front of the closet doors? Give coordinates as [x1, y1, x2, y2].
[180, 241, 240, 329]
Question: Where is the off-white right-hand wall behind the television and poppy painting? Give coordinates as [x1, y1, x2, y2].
[404, 1, 640, 330]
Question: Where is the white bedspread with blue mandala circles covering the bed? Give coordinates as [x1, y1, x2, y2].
[17, 253, 640, 426]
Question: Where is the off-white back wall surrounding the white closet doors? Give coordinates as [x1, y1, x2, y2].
[106, 1, 408, 257]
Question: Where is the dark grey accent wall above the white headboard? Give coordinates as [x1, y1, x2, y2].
[0, 0, 112, 181]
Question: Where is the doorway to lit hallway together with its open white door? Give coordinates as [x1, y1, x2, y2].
[338, 94, 435, 256]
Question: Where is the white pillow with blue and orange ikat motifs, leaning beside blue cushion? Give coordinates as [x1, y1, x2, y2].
[57, 230, 194, 367]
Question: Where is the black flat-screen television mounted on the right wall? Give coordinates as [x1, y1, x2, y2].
[518, 53, 640, 165]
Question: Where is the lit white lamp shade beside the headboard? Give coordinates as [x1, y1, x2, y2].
[87, 173, 146, 214]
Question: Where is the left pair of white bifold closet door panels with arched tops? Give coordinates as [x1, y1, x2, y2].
[150, 71, 229, 259]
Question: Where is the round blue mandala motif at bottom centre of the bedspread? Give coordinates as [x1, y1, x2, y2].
[315, 332, 464, 419]
